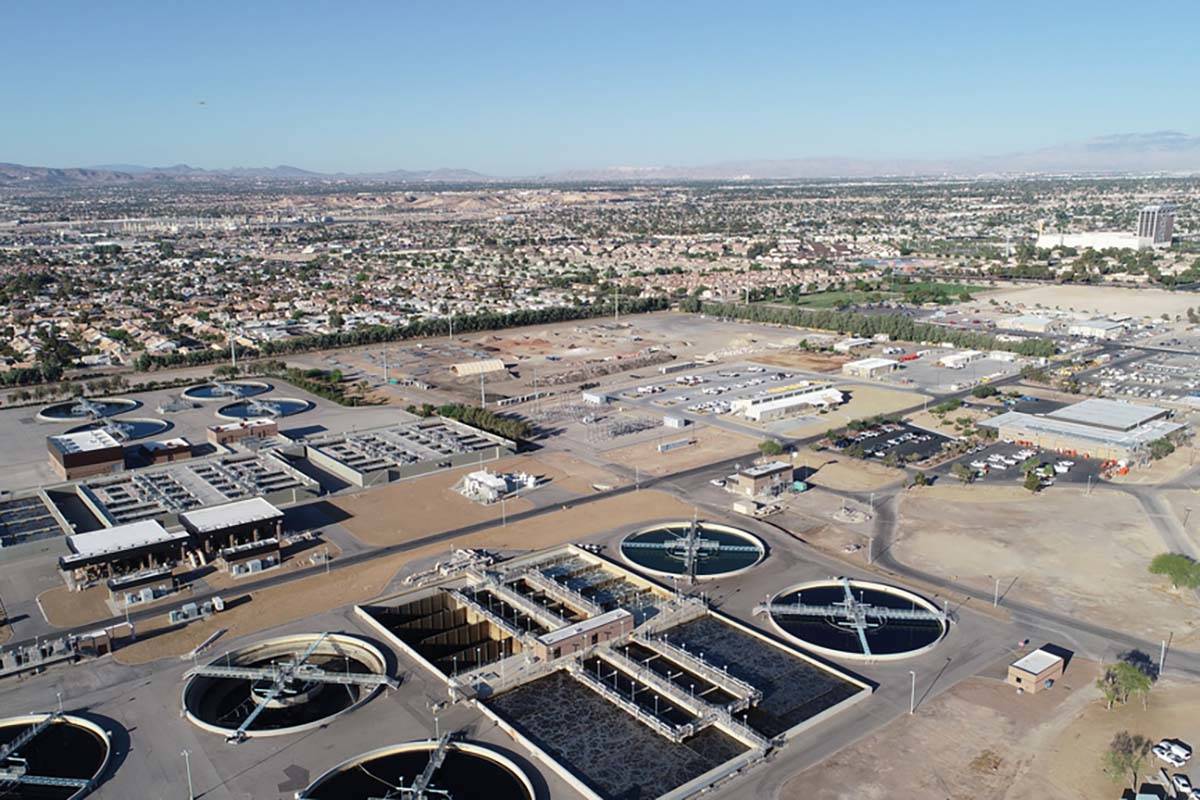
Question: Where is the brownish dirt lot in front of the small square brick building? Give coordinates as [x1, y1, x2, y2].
[779, 660, 1099, 800]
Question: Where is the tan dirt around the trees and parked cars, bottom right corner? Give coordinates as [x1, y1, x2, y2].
[1008, 676, 1200, 800]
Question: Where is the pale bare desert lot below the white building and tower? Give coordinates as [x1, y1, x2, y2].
[979, 285, 1196, 318]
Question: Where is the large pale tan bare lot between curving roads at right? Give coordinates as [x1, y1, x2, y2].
[890, 486, 1200, 643]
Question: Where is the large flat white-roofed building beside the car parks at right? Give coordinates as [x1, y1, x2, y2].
[978, 398, 1183, 459]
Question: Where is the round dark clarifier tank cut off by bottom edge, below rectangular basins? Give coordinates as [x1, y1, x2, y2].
[296, 741, 534, 800]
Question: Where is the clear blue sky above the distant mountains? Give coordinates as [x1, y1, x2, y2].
[0, 0, 1200, 175]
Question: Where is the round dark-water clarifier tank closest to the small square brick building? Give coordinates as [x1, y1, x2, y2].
[769, 578, 949, 661]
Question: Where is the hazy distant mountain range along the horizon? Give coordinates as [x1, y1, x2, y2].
[0, 131, 1200, 186]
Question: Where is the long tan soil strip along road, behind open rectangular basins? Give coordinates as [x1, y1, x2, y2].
[115, 491, 692, 664]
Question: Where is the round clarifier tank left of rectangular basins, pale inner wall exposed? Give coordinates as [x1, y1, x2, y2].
[182, 633, 388, 738]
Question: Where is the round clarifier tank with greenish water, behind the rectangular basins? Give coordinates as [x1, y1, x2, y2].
[620, 521, 767, 578]
